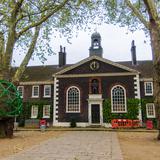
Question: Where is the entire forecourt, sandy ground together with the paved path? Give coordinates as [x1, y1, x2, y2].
[0, 131, 160, 160]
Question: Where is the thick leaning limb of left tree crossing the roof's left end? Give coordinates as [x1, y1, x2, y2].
[12, 26, 40, 82]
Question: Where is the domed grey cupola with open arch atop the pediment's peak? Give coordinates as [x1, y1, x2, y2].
[89, 32, 103, 57]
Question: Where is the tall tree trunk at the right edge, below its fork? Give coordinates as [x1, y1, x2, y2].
[150, 22, 160, 140]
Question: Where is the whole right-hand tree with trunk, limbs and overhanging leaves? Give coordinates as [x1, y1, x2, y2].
[103, 0, 160, 140]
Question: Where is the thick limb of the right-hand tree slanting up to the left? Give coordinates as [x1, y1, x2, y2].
[125, 0, 150, 29]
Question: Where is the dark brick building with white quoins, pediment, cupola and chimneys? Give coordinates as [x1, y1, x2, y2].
[18, 32, 155, 127]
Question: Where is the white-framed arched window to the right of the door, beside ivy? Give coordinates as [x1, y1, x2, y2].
[111, 85, 127, 113]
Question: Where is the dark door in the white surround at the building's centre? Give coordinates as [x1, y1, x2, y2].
[91, 104, 100, 123]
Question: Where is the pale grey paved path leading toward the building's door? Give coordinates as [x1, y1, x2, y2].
[3, 131, 123, 160]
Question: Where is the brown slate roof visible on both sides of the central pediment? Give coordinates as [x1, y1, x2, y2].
[16, 60, 153, 82]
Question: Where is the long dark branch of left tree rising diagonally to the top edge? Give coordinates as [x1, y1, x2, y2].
[17, 0, 69, 38]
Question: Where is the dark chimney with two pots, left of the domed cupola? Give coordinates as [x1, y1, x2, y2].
[59, 46, 66, 67]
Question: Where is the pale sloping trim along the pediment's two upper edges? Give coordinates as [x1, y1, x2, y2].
[55, 55, 139, 75]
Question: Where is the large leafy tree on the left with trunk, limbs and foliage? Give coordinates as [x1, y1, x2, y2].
[0, 0, 97, 138]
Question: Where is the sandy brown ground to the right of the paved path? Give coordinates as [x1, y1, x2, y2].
[118, 132, 160, 160]
